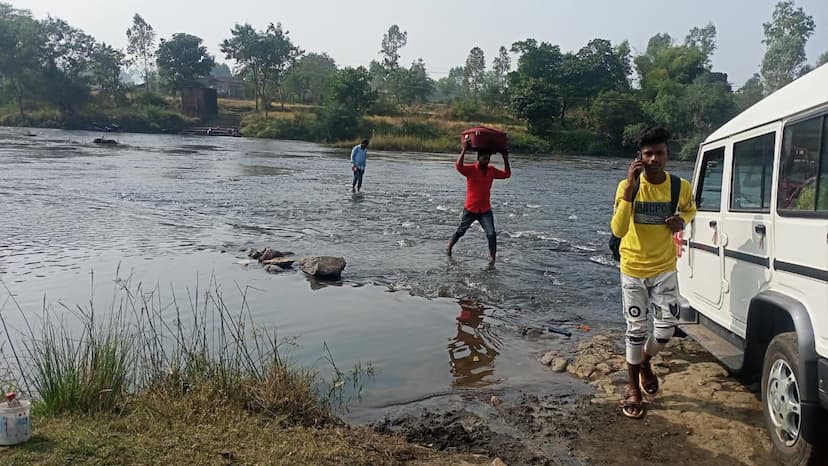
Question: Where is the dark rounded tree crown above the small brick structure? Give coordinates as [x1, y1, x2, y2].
[156, 33, 216, 93]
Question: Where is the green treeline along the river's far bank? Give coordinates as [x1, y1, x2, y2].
[0, 1, 828, 158]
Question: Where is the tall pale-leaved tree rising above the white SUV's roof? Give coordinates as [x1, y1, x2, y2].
[762, 0, 815, 93]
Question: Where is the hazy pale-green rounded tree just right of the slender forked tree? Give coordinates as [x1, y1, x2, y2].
[284, 53, 336, 104]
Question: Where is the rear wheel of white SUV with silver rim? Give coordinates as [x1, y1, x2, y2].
[762, 332, 819, 466]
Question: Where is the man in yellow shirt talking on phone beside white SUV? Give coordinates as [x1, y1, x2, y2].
[612, 126, 696, 419]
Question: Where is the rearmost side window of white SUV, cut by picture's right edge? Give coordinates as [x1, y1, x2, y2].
[778, 116, 828, 214]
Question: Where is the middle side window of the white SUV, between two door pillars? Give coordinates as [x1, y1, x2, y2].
[730, 133, 776, 212]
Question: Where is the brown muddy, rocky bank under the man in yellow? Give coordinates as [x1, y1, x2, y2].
[373, 332, 777, 466]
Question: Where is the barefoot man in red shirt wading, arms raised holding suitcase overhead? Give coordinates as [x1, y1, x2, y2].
[446, 139, 512, 264]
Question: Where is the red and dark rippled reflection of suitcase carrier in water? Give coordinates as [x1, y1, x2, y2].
[448, 299, 503, 387]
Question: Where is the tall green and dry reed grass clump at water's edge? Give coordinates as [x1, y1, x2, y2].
[0, 273, 373, 426]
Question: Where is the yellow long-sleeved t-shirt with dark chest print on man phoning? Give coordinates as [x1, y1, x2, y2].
[612, 173, 696, 278]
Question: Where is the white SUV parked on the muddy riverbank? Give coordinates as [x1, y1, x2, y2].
[678, 65, 828, 465]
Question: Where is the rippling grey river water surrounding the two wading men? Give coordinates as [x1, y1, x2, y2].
[0, 128, 690, 418]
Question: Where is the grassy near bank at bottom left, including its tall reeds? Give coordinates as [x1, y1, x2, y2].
[0, 279, 486, 465]
